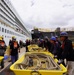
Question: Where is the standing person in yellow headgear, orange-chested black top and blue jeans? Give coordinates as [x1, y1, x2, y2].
[10, 37, 20, 64]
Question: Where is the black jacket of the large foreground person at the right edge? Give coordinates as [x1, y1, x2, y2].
[61, 39, 74, 61]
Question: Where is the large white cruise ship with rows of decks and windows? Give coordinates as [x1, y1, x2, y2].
[0, 0, 31, 45]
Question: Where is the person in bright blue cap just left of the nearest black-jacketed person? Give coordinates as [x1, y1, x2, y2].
[50, 36, 60, 58]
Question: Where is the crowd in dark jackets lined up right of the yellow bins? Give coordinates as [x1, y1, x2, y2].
[26, 32, 74, 75]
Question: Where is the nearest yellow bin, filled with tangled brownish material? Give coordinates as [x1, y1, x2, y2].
[10, 52, 67, 75]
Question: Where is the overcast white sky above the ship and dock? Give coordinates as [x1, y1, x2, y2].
[10, 0, 74, 29]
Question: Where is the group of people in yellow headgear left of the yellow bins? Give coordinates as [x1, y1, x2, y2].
[0, 36, 23, 68]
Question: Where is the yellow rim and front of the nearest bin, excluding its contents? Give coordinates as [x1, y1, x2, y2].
[10, 52, 67, 75]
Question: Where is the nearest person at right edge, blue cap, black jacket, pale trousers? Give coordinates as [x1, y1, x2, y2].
[60, 32, 74, 75]
